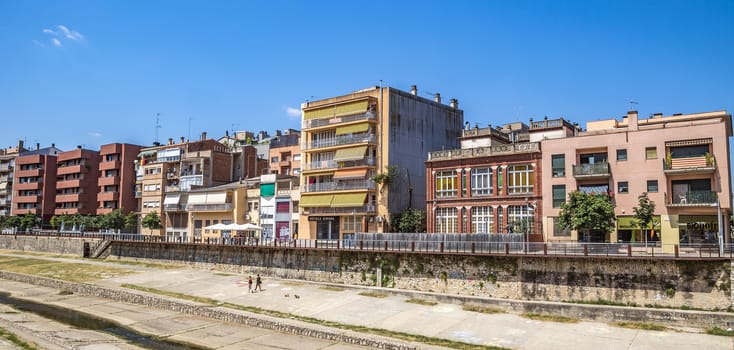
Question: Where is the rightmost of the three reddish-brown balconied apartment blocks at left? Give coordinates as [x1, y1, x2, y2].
[97, 143, 141, 215]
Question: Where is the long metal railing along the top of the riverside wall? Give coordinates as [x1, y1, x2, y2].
[2, 229, 734, 259]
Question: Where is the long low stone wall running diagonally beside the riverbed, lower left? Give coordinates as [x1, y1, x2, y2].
[0, 271, 417, 350]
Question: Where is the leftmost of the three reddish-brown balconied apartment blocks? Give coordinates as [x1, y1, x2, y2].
[11, 144, 61, 225]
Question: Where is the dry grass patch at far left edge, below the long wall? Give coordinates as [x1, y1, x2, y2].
[0, 256, 135, 282]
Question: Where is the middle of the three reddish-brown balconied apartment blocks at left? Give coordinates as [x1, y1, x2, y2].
[54, 146, 99, 215]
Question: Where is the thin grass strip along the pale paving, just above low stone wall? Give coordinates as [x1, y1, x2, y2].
[122, 284, 506, 350]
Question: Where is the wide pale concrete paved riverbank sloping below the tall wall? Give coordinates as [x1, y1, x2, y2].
[0, 254, 734, 350]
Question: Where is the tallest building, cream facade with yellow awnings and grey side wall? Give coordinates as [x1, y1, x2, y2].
[299, 86, 464, 239]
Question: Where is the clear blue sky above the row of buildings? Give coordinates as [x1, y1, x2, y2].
[0, 0, 734, 150]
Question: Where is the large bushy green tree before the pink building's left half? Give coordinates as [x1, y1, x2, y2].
[558, 191, 615, 242]
